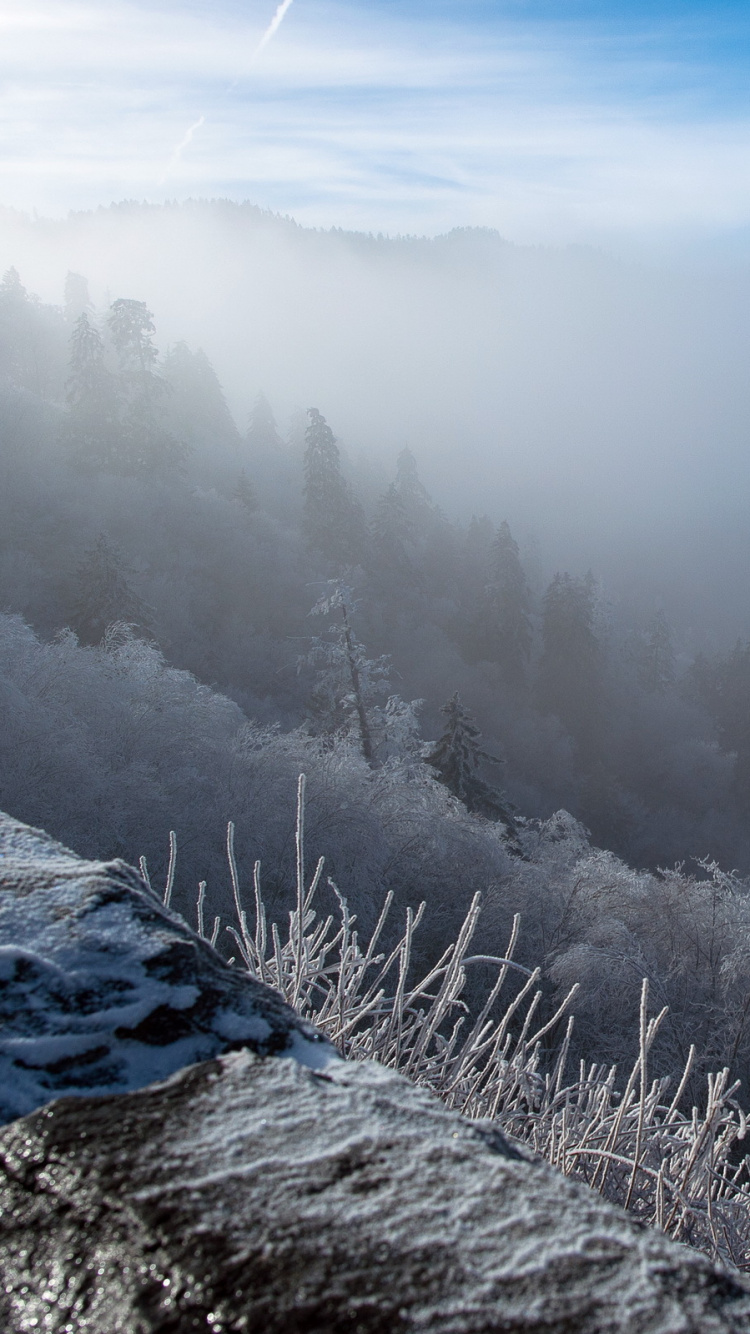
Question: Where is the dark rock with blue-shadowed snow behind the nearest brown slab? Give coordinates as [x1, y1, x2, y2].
[0, 814, 335, 1123]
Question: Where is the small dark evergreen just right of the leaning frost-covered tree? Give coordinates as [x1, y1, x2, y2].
[424, 691, 515, 831]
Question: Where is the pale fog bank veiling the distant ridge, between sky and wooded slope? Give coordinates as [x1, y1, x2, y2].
[0, 201, 750, 647]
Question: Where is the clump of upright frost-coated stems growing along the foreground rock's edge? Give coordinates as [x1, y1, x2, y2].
[148, 778, 750, 1271]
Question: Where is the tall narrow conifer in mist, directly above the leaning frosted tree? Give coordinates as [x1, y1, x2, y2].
[303, 408, 364, 566]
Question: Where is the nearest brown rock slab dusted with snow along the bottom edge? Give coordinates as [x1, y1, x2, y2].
[0, 1051, 750, 1334]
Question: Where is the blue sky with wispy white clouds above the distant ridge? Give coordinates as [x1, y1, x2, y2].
[0, 0, 750, 243]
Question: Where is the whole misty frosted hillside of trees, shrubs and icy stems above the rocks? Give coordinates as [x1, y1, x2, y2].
[0, 208, 750, 1266]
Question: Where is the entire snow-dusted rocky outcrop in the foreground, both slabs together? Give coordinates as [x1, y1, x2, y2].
[0, 819, 750, 1334]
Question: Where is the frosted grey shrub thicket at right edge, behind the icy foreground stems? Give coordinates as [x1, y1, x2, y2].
[512, 816, 750, 1099]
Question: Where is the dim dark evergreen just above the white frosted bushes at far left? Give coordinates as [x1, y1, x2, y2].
[71, 532, 152, 644]
